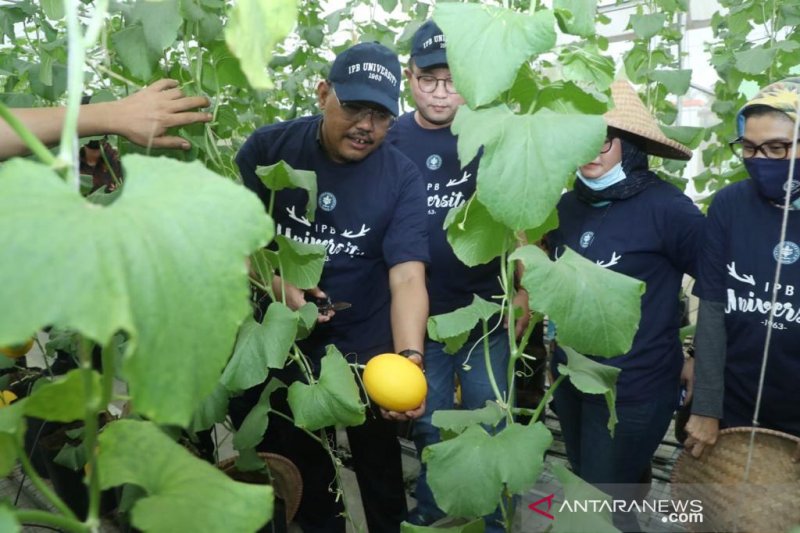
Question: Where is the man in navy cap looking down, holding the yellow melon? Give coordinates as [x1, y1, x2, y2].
[236, 43, 429, 532]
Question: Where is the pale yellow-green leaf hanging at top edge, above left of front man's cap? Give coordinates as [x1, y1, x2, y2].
[225, 0, 297, 89]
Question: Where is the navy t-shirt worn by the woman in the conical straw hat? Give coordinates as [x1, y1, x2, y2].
[542, 180, 703, 402]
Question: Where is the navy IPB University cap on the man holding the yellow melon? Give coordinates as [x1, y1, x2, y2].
[328, 43, 400, 116]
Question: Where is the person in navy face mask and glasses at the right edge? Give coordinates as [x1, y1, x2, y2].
[685, 78, 800, 459]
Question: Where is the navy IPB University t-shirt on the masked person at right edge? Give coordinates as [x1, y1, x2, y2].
[694, 180, 800, 435]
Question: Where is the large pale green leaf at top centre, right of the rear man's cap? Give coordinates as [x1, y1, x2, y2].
[433, 2, 556, 108]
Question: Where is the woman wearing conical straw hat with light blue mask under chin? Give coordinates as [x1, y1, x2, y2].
[548, 80, 703, 531]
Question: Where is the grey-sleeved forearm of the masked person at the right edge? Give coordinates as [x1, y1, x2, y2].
[692, 300, 727, 418]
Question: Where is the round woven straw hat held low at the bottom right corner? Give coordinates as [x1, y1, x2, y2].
[671, 427, 800, 533]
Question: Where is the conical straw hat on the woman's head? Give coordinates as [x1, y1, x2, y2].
[603, 80, 692, 161]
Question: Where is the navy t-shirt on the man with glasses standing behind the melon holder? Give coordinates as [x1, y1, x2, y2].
[387, 111, 502, 316]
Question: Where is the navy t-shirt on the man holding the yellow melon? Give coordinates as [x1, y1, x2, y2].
[236, 116, 429, 362]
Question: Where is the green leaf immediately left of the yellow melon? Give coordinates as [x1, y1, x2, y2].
[289, 345, 366, 431]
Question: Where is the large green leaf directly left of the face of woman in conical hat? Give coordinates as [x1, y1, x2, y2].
[453, 106, 606, 230]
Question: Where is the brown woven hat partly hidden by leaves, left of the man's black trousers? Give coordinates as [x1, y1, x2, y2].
[217, 452, 303, 524]
